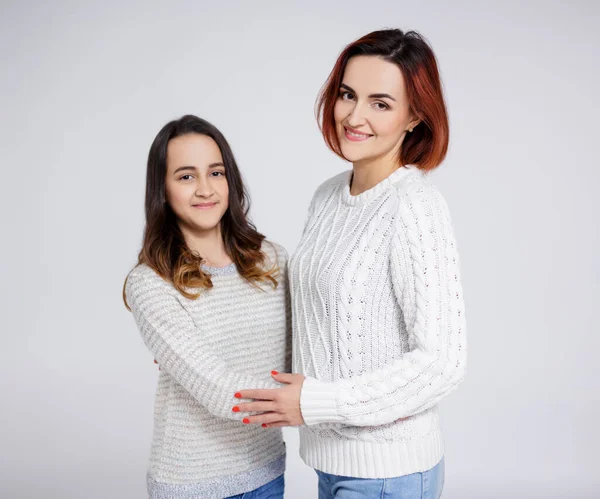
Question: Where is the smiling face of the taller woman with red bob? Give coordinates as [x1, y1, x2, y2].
[334, 56, 419, 164]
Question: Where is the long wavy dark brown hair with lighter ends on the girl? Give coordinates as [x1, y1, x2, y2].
[123, 115, 279, 308]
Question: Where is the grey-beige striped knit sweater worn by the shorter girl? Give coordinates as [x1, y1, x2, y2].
[126, 243, 291, 499]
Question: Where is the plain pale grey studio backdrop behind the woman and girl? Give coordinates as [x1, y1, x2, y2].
[0, 1, 600, 499]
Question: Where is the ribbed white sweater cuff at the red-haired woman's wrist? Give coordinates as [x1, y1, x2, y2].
[300, 377, 343, 426]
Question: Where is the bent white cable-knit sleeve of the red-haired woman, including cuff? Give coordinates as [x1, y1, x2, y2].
[300, 182, 467, 426]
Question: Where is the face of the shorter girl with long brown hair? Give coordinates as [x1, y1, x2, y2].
[165, 133, 229, 236]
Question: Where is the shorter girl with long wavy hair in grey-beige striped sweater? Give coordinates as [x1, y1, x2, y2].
[124, 116, 291, 499]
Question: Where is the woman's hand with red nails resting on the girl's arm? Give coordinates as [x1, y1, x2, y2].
[233, 371, 305, 428]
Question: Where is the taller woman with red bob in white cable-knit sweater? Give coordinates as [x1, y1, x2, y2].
[239, 30, 467, 499]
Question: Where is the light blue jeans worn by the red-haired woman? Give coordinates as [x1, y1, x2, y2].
[317, 459, 444, 499]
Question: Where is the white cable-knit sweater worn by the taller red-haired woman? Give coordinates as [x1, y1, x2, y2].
[290, 166, 467, 478]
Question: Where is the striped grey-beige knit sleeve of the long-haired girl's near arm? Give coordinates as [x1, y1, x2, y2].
[125, 268, 279, 420]
